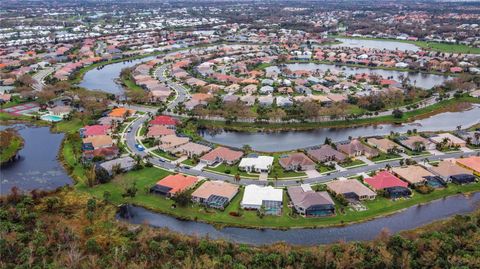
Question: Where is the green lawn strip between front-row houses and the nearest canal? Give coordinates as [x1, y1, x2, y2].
[77, 168, 480, 228]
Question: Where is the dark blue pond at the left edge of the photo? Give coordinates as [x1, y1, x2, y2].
[0, 125, 73, 194]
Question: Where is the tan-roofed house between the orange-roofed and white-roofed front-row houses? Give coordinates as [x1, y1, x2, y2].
[192, 181, 238, 210]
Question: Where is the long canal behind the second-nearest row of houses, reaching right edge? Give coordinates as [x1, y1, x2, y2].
[200, 105, 480, 152]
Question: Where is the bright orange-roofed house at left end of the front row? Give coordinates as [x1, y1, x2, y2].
[150, 174, 198, 197]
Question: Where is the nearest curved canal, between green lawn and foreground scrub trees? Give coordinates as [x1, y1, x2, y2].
[117, 192, 480, 245]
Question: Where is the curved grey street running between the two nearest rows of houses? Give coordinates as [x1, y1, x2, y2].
[124, 115, 478, 187]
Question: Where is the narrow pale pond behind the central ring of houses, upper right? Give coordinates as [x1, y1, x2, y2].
[287, 63, 450, 89]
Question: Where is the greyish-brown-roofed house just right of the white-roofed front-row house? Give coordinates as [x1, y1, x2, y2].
[287, 184, 335, 217]
